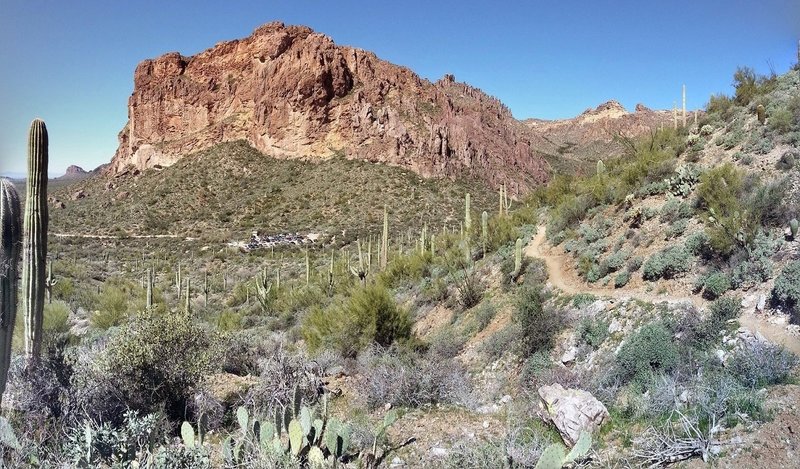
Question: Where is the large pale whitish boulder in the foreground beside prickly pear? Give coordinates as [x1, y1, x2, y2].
[539, 383, 609, 447]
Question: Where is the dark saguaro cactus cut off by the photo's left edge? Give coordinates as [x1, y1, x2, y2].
[0, 179, 22, 399]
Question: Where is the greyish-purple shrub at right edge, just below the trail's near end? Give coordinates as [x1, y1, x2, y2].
[728, 340, 798, 388]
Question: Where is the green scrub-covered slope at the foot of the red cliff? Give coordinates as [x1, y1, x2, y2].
[51, 141, 497, 242]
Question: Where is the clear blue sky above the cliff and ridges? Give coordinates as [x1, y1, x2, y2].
[0, 0, 800, 174]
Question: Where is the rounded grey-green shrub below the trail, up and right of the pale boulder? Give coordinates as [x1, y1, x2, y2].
[616, 322, 679, 380]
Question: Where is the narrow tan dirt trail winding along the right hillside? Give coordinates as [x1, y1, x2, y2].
[524, 226, 800, 355]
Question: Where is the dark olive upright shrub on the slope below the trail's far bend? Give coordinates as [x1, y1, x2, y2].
[513, 287, 565, 357]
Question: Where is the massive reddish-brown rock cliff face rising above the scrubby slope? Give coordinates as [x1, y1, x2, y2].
[109, 23, 552, 192]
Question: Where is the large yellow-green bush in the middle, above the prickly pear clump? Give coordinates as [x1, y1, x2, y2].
[302, 283, 411, 356]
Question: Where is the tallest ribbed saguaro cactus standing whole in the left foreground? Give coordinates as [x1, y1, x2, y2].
[22, 119, 49, 362]
